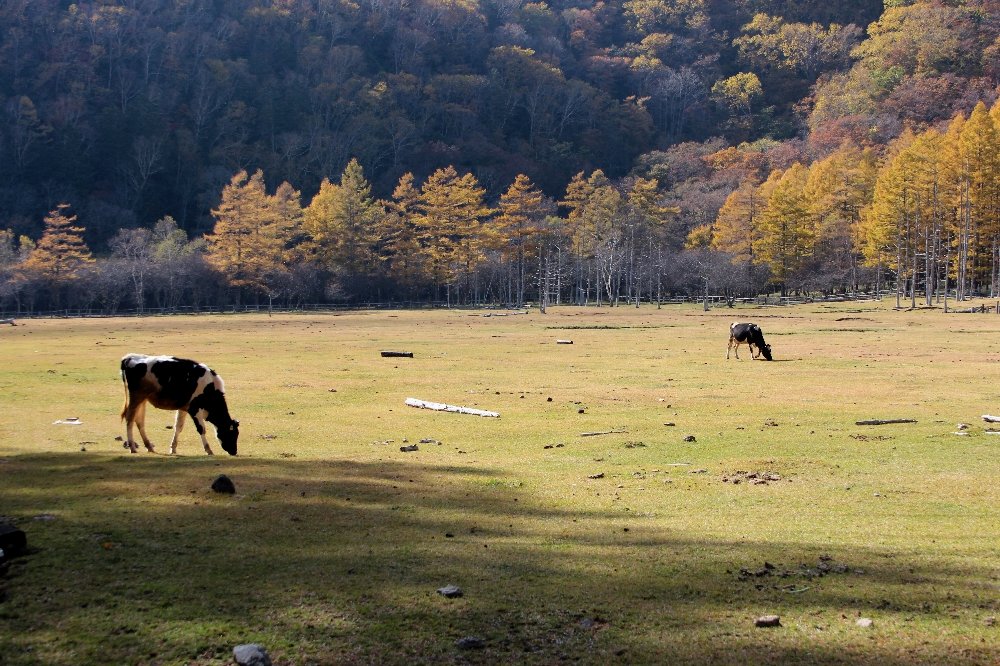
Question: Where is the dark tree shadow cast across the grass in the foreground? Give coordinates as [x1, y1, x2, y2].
[0, 454, 997, 666]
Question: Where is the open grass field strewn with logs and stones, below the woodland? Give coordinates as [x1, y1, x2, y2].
[0, 303, 1000, 666]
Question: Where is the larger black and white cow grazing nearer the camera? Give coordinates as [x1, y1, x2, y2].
[122, 354, 240, 456]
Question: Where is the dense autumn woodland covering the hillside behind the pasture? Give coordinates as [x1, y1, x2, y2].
[0, 0, 1000, 312]
